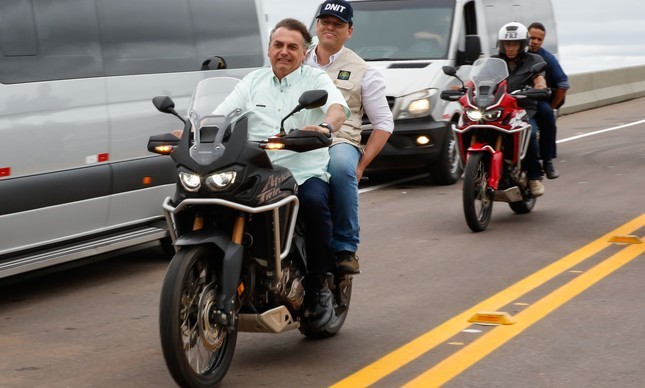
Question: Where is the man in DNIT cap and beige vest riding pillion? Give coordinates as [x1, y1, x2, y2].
[305, 0, 394, 274]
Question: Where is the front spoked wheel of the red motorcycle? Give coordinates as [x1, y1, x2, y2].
[463, 152, 493, 232]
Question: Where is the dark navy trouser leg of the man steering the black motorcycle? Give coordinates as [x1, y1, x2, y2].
[298, 178, 336, 275]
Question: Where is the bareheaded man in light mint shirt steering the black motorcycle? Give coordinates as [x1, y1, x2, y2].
[187, 18, 350, 330]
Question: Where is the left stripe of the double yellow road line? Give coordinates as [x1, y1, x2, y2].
[332, 214, 645, 388]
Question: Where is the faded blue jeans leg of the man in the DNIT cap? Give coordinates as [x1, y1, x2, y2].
[328, 143, 361, 252]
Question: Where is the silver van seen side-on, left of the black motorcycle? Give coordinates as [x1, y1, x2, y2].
[0, 0, 268, 278]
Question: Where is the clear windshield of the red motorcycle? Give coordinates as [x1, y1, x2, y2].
[470, 58, 508, 107]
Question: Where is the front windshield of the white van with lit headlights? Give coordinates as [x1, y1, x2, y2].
[346, 0, 455, 61]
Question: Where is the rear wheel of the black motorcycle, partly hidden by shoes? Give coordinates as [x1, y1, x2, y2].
[300, 275, 353, 339]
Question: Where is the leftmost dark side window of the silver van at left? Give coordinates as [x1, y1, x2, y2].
[0, 0, 103, 84]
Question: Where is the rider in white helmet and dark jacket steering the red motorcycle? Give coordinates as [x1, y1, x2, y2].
[493, 22, 546, 197]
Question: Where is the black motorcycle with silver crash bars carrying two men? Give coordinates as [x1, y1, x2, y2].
[148, 78, 352, 387]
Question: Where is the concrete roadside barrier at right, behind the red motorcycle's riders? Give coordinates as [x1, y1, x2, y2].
[560, 65, 645, 114]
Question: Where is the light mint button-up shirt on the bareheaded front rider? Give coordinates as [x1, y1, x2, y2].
[216, 66, 350, 185]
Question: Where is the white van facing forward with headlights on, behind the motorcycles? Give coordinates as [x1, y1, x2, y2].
[324, 0, 557, 184]
